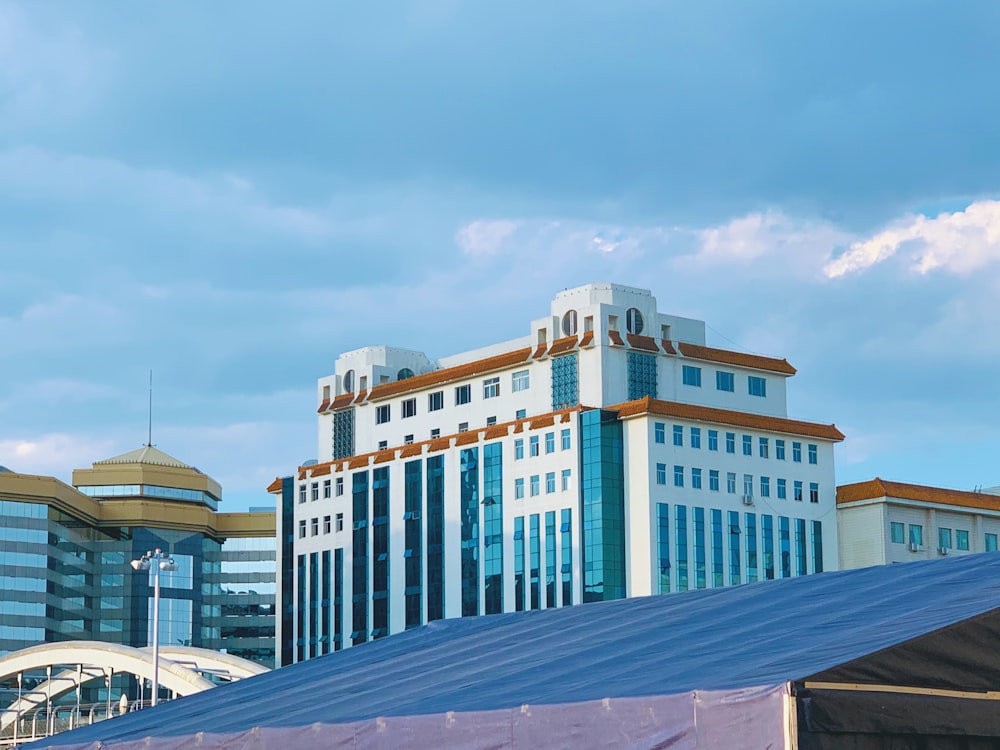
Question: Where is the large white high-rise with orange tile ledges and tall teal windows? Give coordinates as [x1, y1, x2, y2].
[270, 284, 843, 663]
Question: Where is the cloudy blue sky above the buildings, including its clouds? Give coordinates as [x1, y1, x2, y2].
[0, 0, 1000, 510]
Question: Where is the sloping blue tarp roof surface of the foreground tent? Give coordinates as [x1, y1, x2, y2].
[39, 553, 1000, 746]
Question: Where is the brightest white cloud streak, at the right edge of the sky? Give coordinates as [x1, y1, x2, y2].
[823, 200, 1000, 278]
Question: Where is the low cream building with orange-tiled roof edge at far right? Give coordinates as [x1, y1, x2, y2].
[837, 477, 1000, 568]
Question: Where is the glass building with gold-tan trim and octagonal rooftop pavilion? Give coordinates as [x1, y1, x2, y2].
[0, 446, 276, 666]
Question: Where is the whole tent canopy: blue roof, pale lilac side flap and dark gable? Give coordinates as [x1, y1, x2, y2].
[36, 553, 1000, 750]
